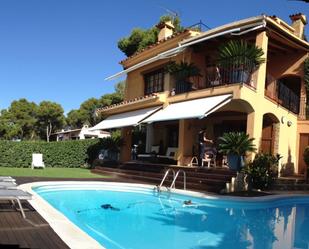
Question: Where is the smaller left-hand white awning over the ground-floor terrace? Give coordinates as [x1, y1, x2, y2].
[90, 106, 162, 130]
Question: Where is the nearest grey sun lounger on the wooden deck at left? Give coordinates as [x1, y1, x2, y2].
[0, 189, 32, 219]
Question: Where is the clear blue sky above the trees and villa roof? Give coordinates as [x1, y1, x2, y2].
[0, 0, 309, 112]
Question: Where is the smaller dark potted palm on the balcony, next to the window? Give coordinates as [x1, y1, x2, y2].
[166, 61, 201, 93]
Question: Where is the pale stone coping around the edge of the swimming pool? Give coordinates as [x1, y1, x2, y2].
[19, 181, 309, 249]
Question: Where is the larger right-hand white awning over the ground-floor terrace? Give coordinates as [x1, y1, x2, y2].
[142, 94, 232, 123]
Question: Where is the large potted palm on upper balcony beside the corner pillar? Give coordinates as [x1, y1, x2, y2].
[219, 40, 265, 83]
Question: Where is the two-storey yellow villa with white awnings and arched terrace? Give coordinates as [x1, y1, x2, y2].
[96, 13, 309, 174]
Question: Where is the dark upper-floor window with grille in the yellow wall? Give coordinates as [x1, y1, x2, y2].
[144, 69, 164, 95]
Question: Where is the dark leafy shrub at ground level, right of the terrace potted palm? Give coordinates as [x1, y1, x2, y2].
[244, 153, 281, 190]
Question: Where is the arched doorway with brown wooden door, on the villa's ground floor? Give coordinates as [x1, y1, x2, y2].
[260, 113, 280, 154]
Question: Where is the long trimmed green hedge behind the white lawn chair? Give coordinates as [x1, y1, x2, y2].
[0, 139, 99, 168]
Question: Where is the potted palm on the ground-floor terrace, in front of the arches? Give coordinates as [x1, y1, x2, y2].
[219, 132, 256, 171]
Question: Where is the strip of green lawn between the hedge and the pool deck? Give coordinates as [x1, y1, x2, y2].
[0, 167, 108, 178]
